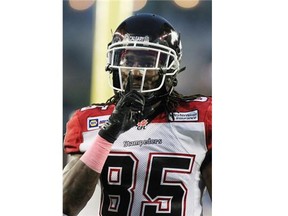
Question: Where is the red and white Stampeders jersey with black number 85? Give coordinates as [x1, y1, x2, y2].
[64, 97, 212, 216]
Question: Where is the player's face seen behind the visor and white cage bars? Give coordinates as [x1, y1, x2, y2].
[120, 50, 161, 91]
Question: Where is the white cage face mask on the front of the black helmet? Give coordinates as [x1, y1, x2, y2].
[107, 41, 179, 93]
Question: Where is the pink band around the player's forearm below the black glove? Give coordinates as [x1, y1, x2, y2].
[80, 135, 112, 173]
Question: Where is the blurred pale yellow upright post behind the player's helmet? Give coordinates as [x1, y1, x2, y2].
[90, 0, 134, 103]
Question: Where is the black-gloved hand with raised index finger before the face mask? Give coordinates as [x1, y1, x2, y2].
[99, 73, 145, 143]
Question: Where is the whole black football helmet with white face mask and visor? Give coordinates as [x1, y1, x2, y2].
[106, 14, 182, 100]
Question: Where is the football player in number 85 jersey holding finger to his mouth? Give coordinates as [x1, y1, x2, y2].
[63, 13, 212, 216]
